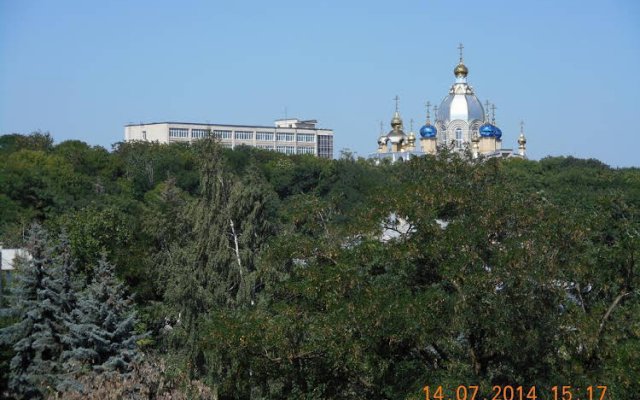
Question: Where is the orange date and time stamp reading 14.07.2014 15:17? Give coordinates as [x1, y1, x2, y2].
[422, 385, 609, 400]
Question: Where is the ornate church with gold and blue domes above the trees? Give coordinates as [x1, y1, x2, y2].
[371, 44, 527, 162]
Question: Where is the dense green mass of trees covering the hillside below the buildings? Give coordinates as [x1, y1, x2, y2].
[0, 133, 640, 399]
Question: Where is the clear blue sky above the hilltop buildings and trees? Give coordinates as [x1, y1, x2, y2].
[0, 0, 640, 166]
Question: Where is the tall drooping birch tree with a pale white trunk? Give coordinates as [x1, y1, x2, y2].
[160, 140, 273, 382]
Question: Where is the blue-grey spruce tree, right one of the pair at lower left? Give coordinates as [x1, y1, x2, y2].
[62, 256, 142, 374]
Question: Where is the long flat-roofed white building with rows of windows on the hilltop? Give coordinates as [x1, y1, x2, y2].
[124, 118, 333, 158]
